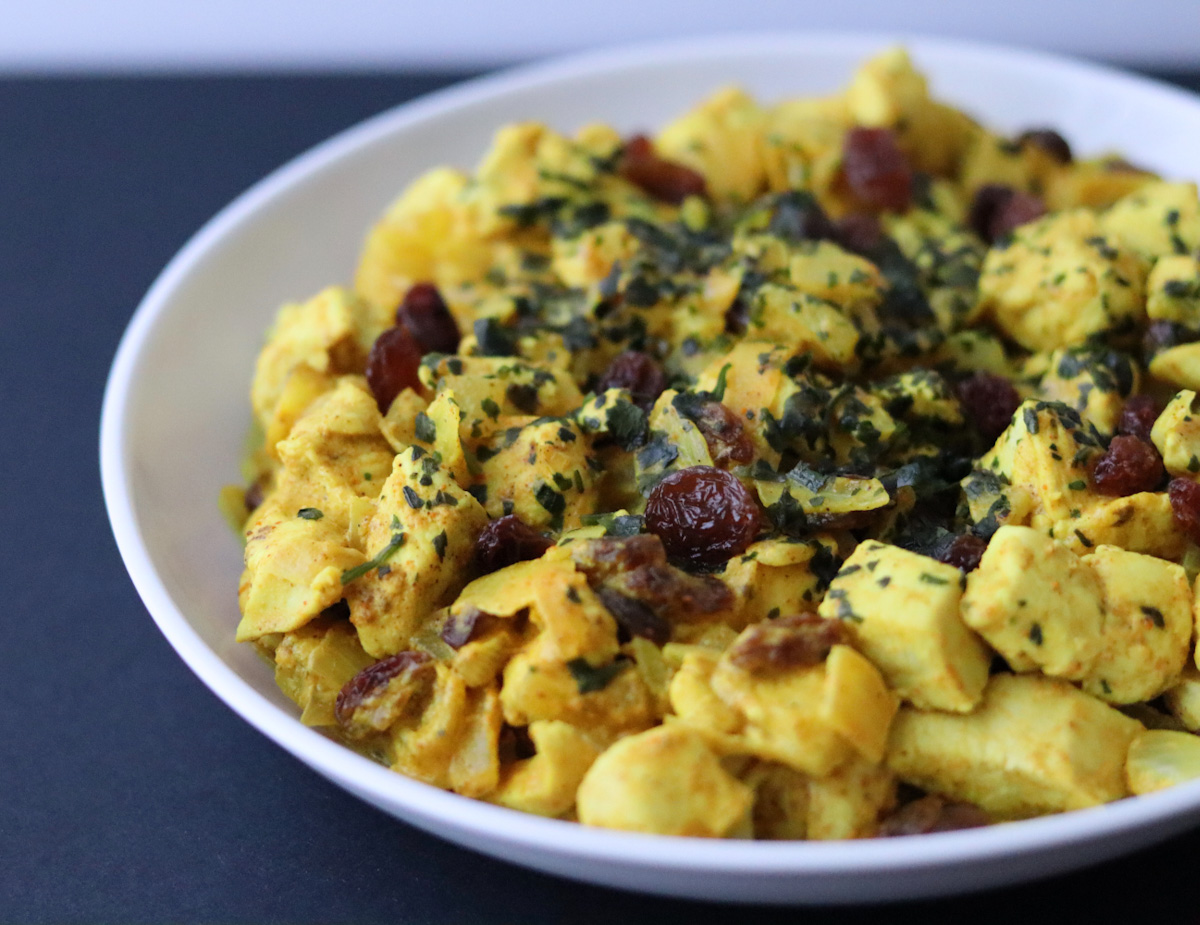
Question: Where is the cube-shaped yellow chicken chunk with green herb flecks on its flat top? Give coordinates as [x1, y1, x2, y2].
[818, 540, 991, 713]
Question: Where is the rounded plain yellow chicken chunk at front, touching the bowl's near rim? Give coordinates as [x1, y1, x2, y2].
[577, 723, 754, 839]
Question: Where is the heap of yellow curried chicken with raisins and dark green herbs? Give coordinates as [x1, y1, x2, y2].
[223, 50, 1200, 839]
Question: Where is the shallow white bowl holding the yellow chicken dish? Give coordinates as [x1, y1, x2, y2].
[101, 35, 1200, 902]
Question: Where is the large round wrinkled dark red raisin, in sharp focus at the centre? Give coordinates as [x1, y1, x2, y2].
[646, 465, 762, 566]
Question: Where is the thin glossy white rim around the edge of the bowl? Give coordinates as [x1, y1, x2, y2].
[98, 31, 1200, 877]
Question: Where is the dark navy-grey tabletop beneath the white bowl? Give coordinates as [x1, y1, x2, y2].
[9, 66, 1200, 925]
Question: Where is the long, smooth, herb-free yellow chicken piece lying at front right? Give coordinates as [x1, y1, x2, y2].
[887, 674, 1141, 819]
